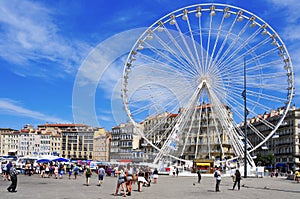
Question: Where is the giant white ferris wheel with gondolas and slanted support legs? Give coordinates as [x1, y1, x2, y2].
[122, 4, 294, 167]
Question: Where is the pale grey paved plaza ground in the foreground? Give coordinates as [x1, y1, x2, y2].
[0, 174, 300, 199]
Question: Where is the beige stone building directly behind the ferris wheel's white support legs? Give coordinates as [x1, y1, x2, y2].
[141, 104, 234, 161]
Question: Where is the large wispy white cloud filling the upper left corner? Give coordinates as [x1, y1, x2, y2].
[0, 0, 89, 77]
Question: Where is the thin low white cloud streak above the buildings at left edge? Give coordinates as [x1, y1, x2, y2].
[0, 99, 70, 123]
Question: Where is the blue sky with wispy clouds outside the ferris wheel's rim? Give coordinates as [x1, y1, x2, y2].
[0, 0, 300, 130]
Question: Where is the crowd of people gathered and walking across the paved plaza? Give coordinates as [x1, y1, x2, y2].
[0, 161, 300, 197]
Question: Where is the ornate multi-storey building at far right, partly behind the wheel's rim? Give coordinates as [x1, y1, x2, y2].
[248, 106, 300, 171]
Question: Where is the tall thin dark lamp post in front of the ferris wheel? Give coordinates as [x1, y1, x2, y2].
[242, 57, 248, 178]
